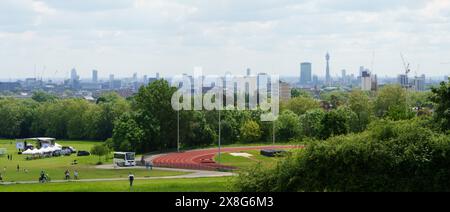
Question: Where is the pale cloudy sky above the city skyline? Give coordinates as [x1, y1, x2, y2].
[0, 0, 450, 79]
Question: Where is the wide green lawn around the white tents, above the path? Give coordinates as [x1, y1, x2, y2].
[0, 140, 186, 182]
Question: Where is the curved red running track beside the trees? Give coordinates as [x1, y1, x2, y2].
[152, 146, 302, 170]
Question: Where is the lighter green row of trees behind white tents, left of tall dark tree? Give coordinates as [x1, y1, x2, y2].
[0, 92, 130, 140]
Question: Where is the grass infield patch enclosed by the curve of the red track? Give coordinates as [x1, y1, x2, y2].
[214, 150, 278, 168]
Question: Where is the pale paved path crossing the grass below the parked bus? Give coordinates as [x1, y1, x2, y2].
[0, 165, 235, 185]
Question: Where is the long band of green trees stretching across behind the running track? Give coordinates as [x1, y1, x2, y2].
[0, 80, 432, 153]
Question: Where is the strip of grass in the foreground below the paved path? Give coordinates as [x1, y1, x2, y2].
[0, 177, 230, 192]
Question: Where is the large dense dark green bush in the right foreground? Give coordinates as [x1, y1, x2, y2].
[233, 120, 450, 192]
